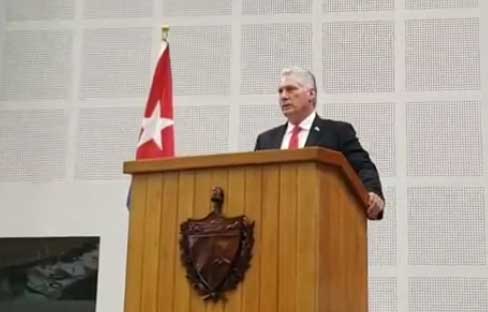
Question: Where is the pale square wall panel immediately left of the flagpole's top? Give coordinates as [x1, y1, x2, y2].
[79, 27, 152, 100]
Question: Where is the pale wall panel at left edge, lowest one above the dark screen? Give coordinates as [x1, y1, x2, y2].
[0, 109, 68, 183]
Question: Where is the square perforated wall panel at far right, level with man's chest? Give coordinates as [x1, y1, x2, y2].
[406, 101, 486, 176]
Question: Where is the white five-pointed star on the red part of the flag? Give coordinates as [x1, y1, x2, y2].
[137, 101, 174, 150]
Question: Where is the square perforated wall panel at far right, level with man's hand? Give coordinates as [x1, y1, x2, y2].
[407, 186, 487, 265]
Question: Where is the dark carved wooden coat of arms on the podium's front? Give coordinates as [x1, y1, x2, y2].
[180, 187, 254, 301]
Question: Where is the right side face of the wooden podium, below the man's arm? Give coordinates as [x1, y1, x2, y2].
[319, 168, 368, 312]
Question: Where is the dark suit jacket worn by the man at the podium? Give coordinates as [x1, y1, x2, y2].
[255, 116, 384, 205]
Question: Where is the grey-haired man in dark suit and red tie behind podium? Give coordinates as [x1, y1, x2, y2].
[255, 67, 385, 220]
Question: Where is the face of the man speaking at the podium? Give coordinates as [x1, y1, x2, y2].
[278, 75, 315, 124]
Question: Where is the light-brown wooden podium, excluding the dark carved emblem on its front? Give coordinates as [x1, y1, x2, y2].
[124, 148, 368, 312]
